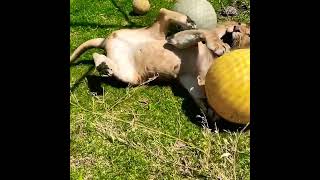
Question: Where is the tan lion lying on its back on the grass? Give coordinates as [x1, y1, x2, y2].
[70, 8, 250, 121]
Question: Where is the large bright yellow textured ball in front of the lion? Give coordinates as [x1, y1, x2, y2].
[205, 49, 250, 124]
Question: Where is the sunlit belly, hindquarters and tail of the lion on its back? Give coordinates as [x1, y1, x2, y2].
[70, 8, 195, 85]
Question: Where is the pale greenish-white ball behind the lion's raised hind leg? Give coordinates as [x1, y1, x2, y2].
[172, 0, 217, 29]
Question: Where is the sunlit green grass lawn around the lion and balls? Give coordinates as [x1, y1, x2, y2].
[70, 0, 250, 179]
